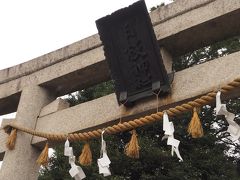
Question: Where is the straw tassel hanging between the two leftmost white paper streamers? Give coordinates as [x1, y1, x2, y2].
[79, 142, 92, 166]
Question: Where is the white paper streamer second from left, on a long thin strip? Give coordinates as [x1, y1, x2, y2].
[97, 131, 111, 177]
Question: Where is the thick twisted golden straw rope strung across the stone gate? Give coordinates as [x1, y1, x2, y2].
[4, 78, 240, 141]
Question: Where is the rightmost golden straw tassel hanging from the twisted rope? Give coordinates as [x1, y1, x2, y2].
[188, 107, 203, 138]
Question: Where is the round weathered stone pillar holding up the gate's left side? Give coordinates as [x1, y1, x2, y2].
[0, 86, 54, 180]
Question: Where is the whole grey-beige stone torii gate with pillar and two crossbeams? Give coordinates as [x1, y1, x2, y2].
[0, 0, 240, 180]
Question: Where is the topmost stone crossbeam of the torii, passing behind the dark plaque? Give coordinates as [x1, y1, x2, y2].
[0, 0, 240, 114]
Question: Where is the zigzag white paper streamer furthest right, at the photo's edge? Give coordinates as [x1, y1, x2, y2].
[216, 91, 240, 141]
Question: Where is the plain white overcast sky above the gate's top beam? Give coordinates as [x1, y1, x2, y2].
[0, 0, 171, 69]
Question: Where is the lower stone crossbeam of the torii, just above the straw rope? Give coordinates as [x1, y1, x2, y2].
[32, 52, 240, 144]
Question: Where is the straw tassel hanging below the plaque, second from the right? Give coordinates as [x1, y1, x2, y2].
[125, 129, 140, 159]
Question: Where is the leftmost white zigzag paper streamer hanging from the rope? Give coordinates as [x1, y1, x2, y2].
[64, 139, 86, 180]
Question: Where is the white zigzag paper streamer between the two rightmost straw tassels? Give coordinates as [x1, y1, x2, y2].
[162, 112, 183, 162]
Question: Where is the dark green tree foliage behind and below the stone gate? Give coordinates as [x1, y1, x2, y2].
[39, 8, 240, 180]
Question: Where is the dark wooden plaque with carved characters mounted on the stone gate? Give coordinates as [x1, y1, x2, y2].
[96, 0, 170, 106]
